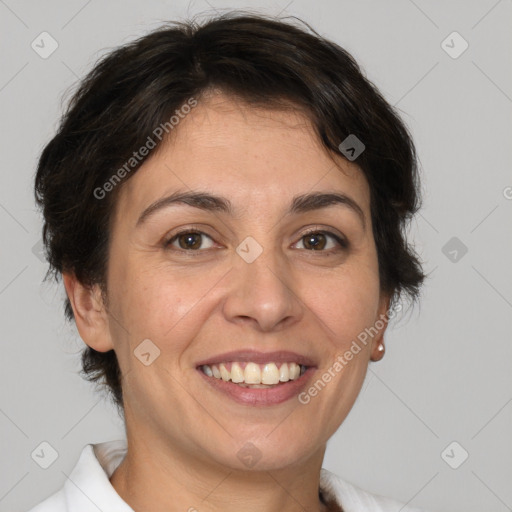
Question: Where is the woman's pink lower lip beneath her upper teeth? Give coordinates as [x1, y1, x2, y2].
[197, 367, 315, 405]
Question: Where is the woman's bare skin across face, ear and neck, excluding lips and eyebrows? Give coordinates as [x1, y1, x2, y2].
[64, 93, 389, 512]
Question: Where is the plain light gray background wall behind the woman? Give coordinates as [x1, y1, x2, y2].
[0, 0, 512, 512]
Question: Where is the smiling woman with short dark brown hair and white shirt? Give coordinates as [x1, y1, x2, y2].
[28, 13, 424, 512]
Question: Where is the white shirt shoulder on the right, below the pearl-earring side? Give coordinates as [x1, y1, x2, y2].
[320, 468, 427, 512]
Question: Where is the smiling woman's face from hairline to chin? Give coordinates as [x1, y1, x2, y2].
[70, 91, 388, 469]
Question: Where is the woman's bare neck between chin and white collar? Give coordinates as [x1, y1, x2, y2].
[110, 426, 330, 512]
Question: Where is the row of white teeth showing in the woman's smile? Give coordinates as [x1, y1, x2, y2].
[201, 362, 306, 388]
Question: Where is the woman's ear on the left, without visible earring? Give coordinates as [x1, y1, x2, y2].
[62, 273, 114, 352]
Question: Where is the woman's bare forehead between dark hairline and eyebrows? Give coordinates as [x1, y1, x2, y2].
[114, 94, 369, 221]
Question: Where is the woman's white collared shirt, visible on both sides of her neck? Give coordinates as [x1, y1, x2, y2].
[28, 439, 428, 512]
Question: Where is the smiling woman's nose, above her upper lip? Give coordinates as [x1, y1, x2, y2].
[223, 243, 304, 332]
